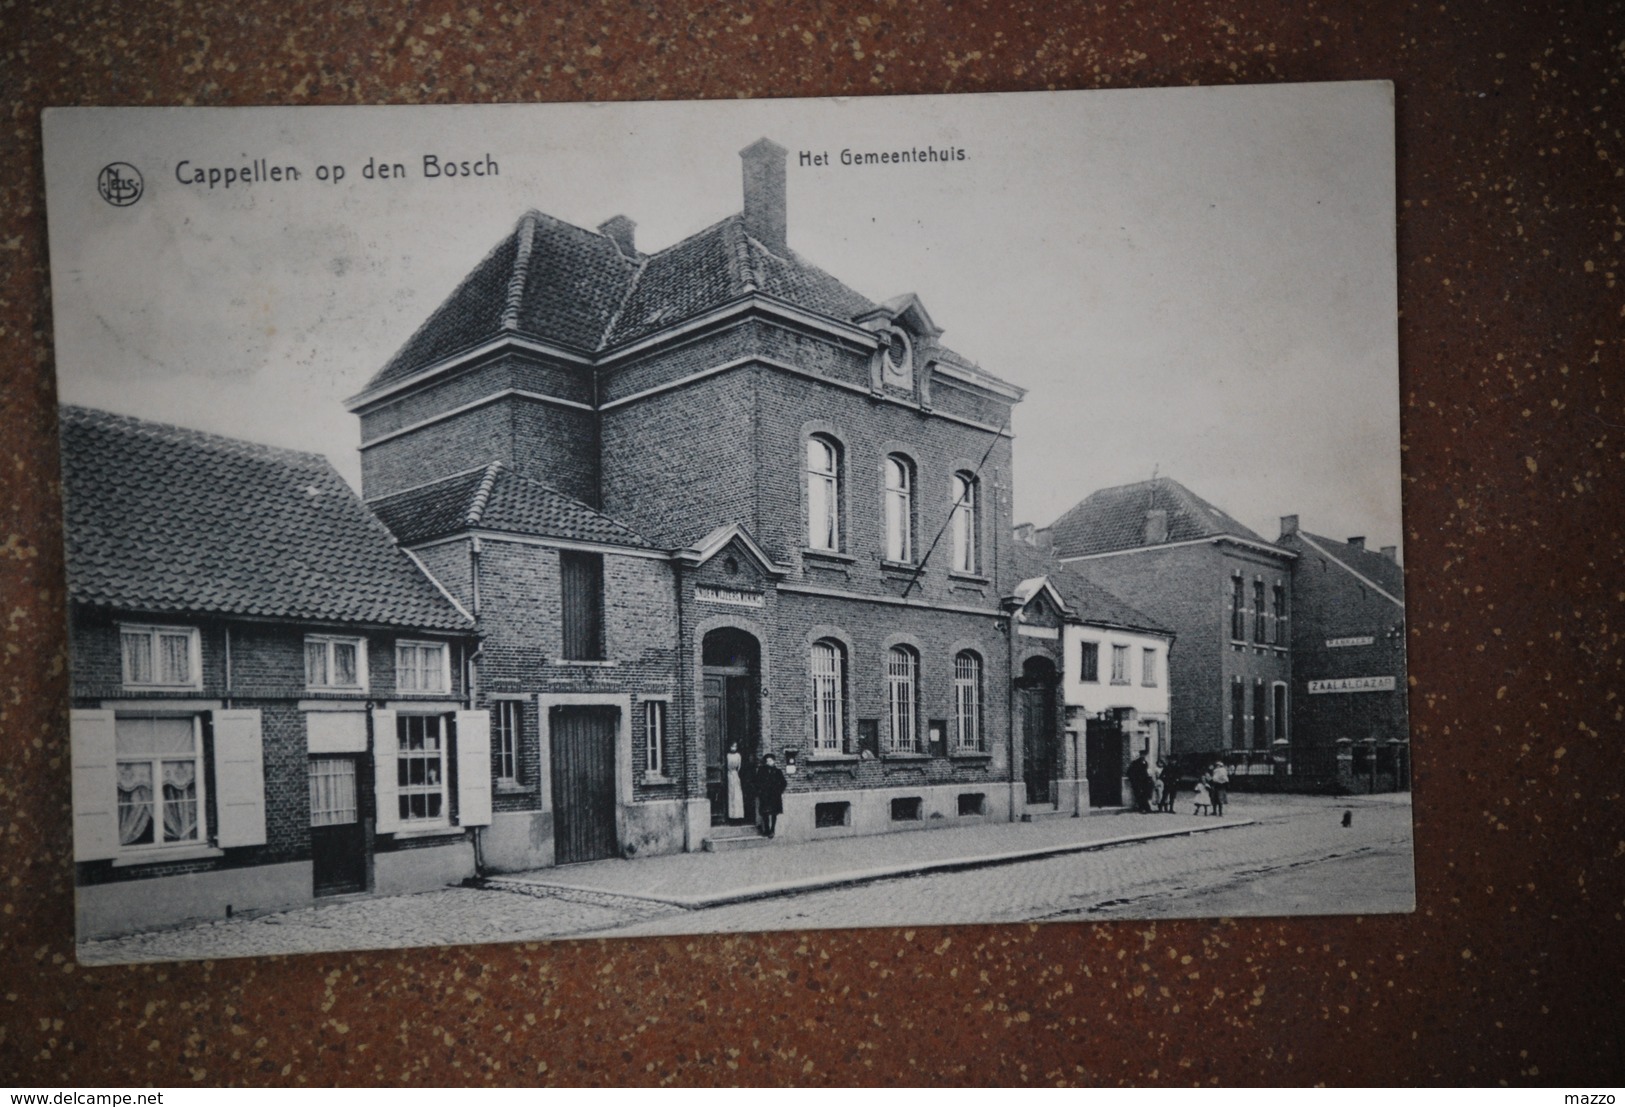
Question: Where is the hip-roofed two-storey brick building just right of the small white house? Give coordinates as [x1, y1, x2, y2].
[1042, 478, 1298, 772]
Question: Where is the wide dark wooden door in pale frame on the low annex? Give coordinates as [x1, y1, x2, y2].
[549, 707, 621, 865]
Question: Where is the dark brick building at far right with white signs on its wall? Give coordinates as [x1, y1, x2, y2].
[1276, 515, 1411, 787]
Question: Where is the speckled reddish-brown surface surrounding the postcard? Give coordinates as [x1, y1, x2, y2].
[0, 0, 1625, 1086]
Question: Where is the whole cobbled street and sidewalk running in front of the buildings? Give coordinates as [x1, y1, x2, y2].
[78, 795, 1414, 966]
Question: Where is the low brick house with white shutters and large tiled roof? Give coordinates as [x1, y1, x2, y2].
[60, 406, 491, 940]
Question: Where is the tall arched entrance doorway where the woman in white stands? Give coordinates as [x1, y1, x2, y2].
[700, 627, 762, 826]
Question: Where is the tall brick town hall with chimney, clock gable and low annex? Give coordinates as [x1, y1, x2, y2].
[349, 140, 1033, 868]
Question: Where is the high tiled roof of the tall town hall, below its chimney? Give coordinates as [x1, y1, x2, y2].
[364, 211, 998, 393]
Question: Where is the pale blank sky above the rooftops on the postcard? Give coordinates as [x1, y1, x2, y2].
[46, 81, 1404, 548]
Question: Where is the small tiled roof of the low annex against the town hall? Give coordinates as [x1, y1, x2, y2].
[369, 462, 648, 549]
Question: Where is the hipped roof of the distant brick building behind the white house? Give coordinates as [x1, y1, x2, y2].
[1050, 478, 1271, 558]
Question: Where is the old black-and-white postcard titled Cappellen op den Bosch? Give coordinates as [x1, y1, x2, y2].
[44, 83, 1414, 962]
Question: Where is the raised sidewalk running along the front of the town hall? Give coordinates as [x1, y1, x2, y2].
[481, 803, 1255, 910]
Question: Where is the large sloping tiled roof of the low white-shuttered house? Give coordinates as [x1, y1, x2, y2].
[60, 406, 473, 632]
